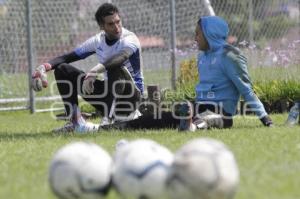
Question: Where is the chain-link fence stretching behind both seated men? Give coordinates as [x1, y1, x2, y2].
[0, 0, 300, 110]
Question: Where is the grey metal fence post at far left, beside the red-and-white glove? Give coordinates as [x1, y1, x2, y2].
[26, 0, 35, 113]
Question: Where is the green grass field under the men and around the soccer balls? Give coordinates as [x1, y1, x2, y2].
[0, 112, 300, 199]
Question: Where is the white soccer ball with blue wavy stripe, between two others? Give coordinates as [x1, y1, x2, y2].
[113, 139, 173, 199]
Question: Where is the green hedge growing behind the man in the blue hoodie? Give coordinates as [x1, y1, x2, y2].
[163, 59, 300, 105]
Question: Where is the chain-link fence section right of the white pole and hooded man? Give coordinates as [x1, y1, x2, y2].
[211, 0, 300, 67]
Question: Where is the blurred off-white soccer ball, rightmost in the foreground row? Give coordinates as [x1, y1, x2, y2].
[167, 138, 239, 199]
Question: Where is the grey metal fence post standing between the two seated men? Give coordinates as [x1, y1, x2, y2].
[170, 0, 176, 90]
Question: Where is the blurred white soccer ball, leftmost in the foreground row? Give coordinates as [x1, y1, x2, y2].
[49, 142, 112, 199]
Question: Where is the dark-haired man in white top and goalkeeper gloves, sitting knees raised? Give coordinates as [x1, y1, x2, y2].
[32, 3, 144, 132]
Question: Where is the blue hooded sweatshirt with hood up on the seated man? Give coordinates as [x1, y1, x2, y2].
[196, 16, 267, 118]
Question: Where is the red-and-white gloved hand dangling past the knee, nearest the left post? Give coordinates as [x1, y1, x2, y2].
[31, 63, 52, 91]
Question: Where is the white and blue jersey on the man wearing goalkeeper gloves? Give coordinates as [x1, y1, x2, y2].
[74, 28, 144, 93]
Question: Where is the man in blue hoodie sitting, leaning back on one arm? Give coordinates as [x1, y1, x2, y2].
[191, 16, 272, 130]
